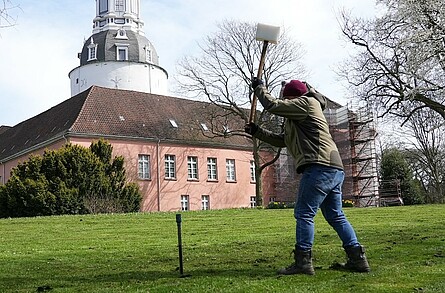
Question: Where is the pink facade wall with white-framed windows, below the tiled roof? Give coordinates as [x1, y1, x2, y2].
[73, 139, 255, 211]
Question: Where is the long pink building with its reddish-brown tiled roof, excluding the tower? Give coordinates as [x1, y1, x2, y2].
[0, 87, 275, 212]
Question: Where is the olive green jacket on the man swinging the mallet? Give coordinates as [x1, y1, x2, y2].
[254, 85, 343, 173]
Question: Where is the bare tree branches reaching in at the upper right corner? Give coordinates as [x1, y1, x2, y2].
[340, 0, 445, 125]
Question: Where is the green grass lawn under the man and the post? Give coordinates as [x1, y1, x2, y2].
[0, 205, 445, 293]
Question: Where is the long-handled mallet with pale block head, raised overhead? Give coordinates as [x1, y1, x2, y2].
[249, 23, 280, 123]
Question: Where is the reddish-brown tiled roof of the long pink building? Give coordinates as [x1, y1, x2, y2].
[0, 86, 251, 160]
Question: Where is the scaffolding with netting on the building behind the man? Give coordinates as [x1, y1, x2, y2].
[275, 102, 380, 207]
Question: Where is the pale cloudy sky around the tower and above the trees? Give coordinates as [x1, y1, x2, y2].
[0, 0, 375, 126]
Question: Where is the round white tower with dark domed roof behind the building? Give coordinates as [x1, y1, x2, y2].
[69, 0, 168, 96]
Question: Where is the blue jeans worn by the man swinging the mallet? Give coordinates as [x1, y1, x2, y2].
[294, 164, 360, 251]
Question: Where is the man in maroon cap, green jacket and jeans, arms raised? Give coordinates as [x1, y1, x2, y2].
[245, 78, 370, 275]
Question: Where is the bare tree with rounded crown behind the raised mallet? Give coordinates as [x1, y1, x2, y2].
[173, 21, 306, 205]
